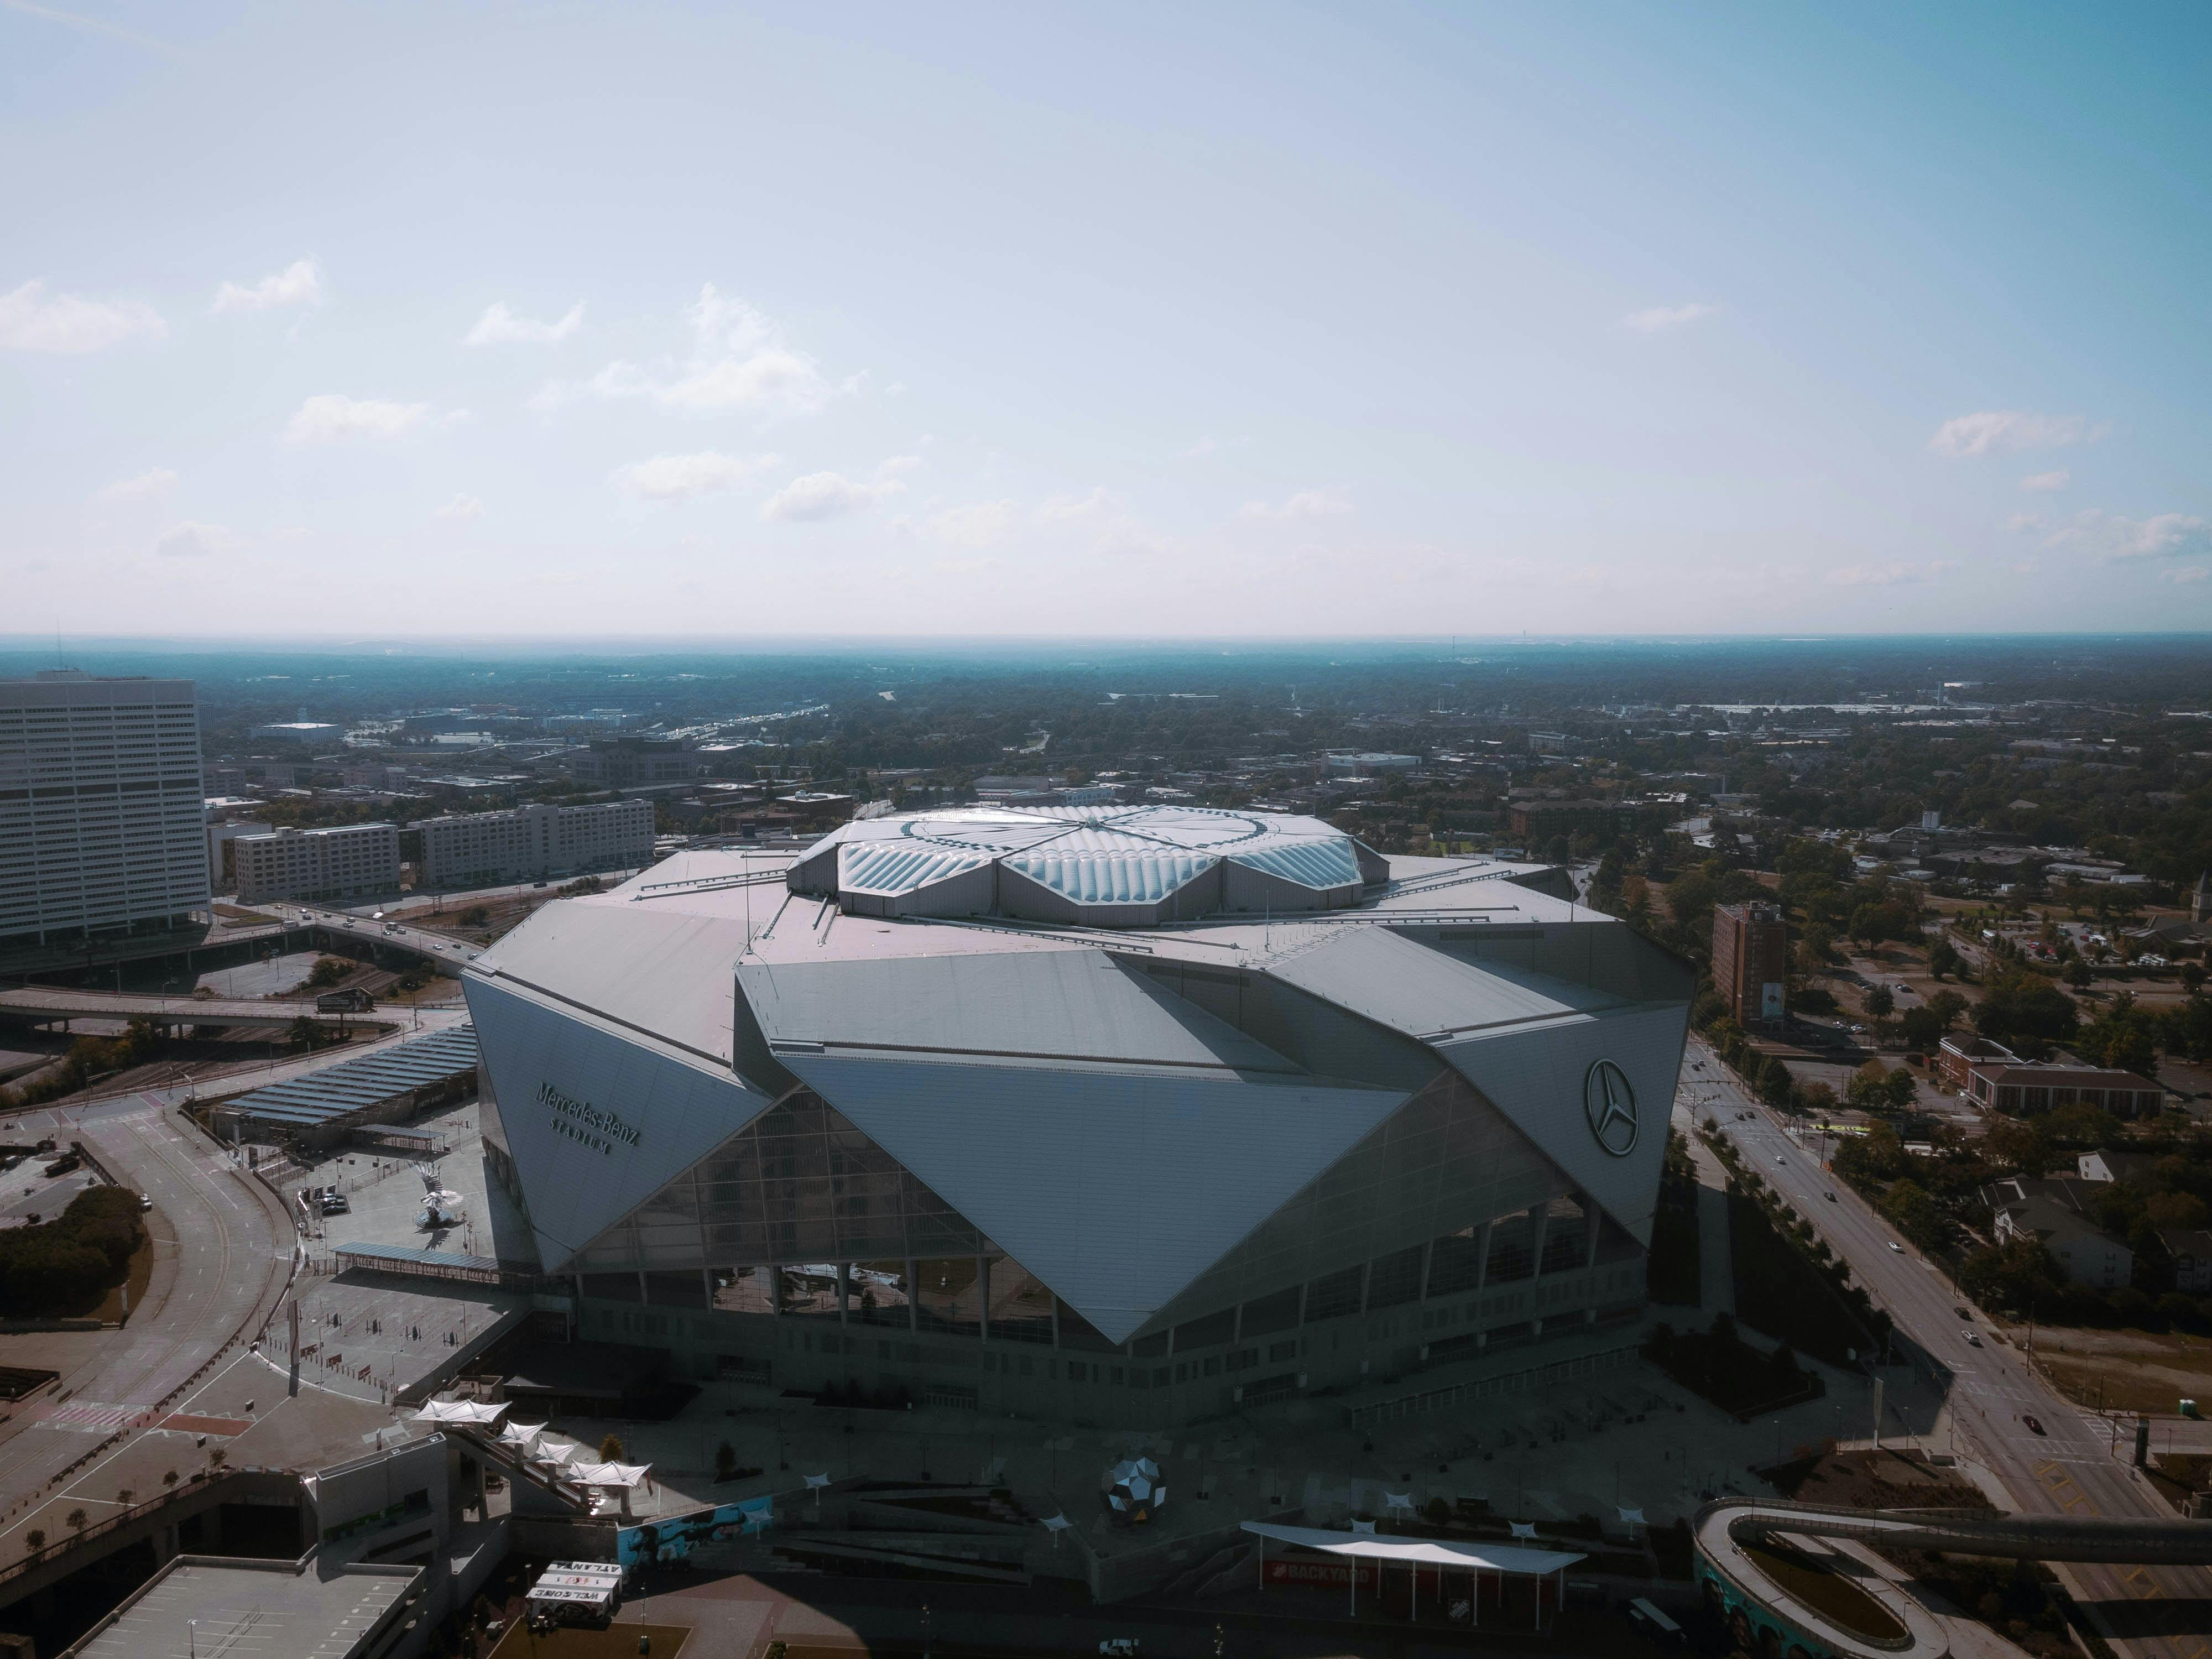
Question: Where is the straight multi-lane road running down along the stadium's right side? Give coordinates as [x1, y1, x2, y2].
[1683, 1037, 2212, 1659]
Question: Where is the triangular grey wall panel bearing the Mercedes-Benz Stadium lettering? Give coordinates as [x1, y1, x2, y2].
[462, 975, 770, 1272]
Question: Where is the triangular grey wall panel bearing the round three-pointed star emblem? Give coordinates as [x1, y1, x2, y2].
[1433, 1004, 1690, 1245]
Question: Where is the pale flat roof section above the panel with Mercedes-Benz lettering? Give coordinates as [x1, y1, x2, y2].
[467, 887, 752, 1062]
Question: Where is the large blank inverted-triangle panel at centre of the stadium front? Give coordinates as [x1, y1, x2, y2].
[781, 1053, 1405, 1343]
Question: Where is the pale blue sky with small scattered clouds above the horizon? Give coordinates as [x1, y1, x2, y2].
[0, 0, 2212, 639]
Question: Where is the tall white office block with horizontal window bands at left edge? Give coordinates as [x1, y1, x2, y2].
[0, 668, 208, 942]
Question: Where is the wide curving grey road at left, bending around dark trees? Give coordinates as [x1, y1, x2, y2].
[0, 1099, 296, 1555]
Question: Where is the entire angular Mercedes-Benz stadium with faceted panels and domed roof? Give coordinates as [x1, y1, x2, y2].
[467, 805, 1692, 1425]
